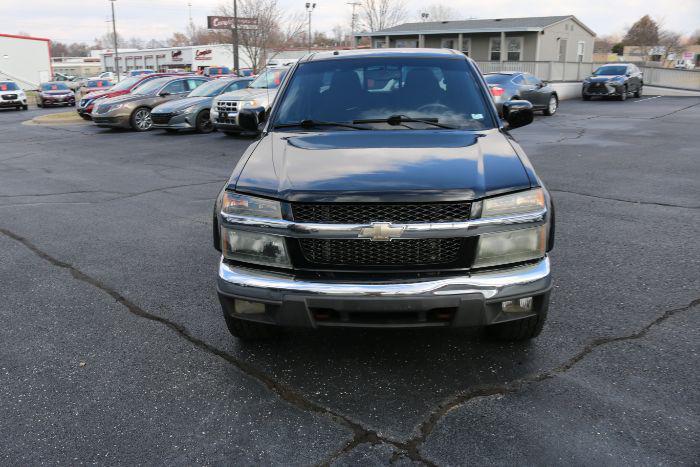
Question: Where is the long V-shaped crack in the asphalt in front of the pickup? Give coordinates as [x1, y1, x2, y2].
[0, 228, 700, 467]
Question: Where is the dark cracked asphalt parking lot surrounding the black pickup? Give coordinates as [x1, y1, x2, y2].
[0, 96, 700, 465]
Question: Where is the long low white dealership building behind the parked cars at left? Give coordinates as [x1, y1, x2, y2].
[101, 44, 251, 71]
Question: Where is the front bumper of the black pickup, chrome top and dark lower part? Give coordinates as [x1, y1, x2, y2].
[217, 257, 552, 327]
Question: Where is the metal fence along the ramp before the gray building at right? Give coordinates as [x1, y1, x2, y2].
[476, 61, 700, 91]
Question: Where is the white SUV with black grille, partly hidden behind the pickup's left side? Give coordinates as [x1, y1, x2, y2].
[210, 67, 290, 135]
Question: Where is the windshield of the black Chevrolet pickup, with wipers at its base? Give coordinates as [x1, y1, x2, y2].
[274, 57, 493, 130]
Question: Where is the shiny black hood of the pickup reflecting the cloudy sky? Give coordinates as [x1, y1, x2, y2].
[229, 130, 531, 202]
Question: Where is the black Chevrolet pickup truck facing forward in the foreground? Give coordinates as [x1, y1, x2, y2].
[213, 49, 554, 340]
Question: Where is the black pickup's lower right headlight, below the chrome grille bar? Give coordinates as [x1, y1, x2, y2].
[473, 225, 547, 268]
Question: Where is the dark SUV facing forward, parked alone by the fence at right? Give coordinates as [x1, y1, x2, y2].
[581, 63, 644, 101]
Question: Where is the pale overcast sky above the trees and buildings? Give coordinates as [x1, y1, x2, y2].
[6, 0, 700, 43]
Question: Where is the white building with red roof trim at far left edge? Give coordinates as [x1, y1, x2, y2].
[0, 34, 53, 90]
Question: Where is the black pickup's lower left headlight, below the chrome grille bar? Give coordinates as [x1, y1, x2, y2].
[221, 227, 291, 268]
